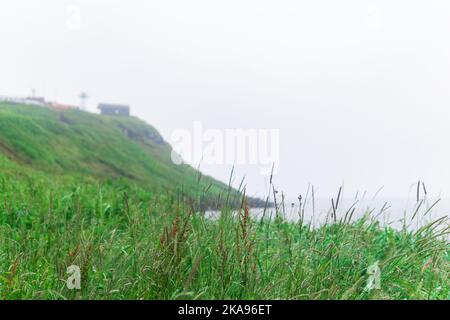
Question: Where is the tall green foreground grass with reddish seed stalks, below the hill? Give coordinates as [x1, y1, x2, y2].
[0, 170, 450, 299]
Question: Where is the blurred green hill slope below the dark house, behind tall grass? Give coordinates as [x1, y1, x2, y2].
[0, 103, 241, 206]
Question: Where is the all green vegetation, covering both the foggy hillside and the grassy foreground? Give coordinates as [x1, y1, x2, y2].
[0, 103, 450, 299]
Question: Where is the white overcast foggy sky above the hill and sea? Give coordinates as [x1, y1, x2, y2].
[0, 0, 450, 197]
